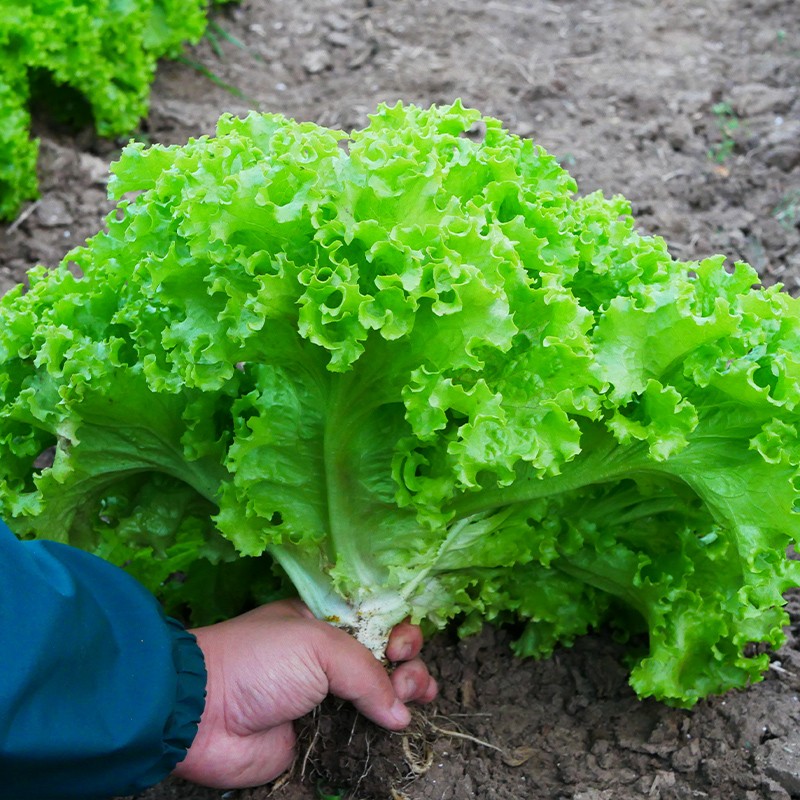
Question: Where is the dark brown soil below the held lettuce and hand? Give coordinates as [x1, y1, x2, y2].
[128, 608, 800, 800]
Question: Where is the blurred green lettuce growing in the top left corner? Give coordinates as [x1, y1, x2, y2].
[0, 0, 225, 219]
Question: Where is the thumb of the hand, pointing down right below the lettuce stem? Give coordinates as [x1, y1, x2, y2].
[316, 624, 411, 730]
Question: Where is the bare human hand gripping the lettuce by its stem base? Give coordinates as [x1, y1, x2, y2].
[173, 600, 437, 789]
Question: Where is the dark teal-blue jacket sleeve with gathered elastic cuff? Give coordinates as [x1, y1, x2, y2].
[0, 523, 206, 800]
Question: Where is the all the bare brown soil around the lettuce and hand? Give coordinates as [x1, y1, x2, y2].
[0, 0, 800, 800]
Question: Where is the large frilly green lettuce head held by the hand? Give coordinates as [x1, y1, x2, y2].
[0, 103, 800, 706]
